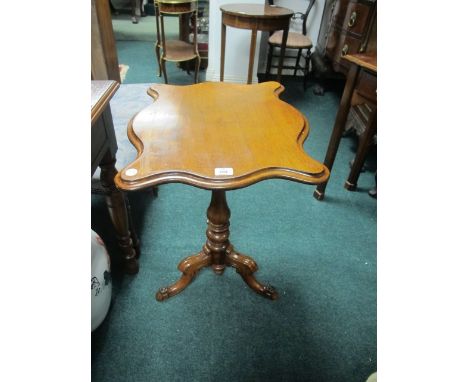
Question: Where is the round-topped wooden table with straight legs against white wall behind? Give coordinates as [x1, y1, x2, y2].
[220, 4, 294, 84]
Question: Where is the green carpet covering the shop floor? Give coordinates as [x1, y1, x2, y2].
[92, 20, 377, 382]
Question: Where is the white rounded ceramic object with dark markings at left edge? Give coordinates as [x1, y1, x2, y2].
[91, 230, 112, 331]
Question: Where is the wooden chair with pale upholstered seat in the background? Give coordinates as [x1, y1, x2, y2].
[267, 0, 315, 90]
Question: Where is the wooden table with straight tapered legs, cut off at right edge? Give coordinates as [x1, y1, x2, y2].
[314, 53, 377, 200]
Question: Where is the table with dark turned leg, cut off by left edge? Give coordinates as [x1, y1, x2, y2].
[91, 81, 139, 274]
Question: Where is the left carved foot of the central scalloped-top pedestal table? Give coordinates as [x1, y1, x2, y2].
[156, 252, 211, 301]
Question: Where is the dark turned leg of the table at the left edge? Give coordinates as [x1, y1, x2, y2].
[99, 152, 139, 274]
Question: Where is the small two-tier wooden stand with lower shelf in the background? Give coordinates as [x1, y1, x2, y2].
[154, 0, 201, 84]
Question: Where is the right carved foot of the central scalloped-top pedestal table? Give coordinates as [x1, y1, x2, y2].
[226, 251, 278, 300]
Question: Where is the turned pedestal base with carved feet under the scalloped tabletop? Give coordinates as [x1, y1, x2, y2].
[156, 190, 278, 301]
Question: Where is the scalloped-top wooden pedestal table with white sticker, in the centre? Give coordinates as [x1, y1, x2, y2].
[115, 82, 329, 301]
